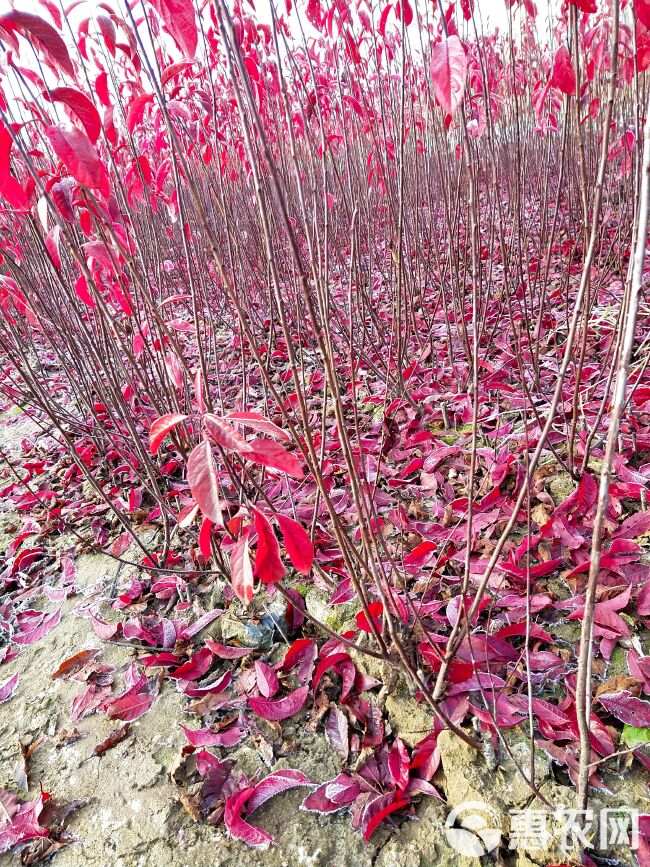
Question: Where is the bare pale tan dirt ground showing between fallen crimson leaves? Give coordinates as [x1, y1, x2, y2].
[0, 410, 650, 867]
